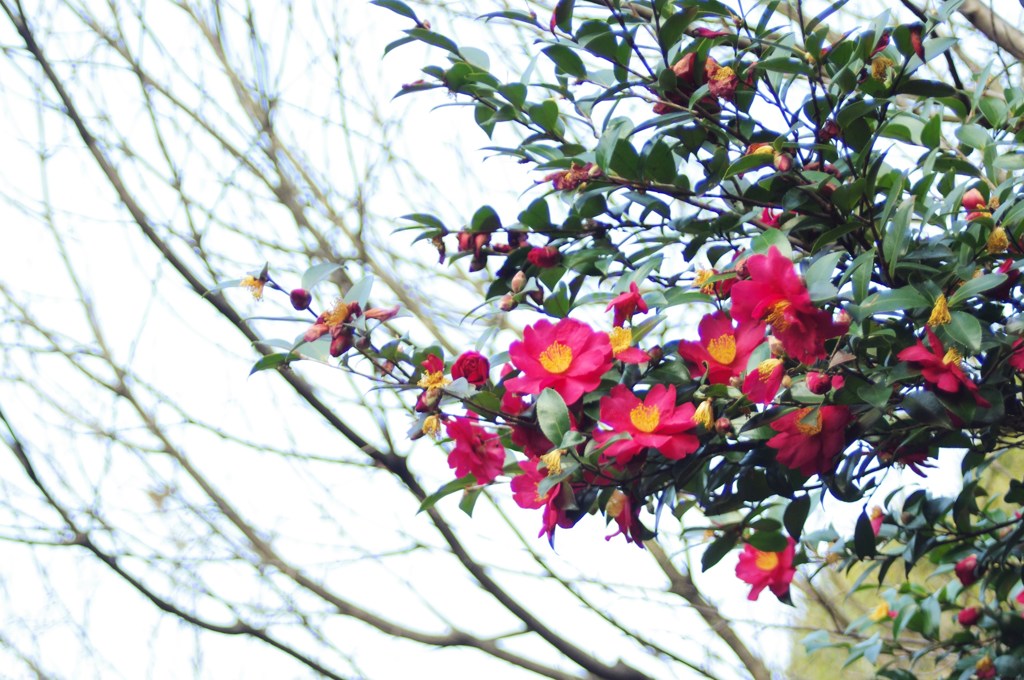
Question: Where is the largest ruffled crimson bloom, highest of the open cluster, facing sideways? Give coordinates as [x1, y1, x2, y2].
[732, 246, 848, 364]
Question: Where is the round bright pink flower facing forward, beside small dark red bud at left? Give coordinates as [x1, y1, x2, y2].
[505, 318, 611, 403]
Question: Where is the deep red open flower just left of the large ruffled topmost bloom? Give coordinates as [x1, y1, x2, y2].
[679, 311, 765, 385]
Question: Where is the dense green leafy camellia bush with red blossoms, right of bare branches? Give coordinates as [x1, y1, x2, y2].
[234, 0, 1024, 678]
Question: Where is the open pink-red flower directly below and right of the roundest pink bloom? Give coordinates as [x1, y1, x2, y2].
[594, 385, 700, 464]
